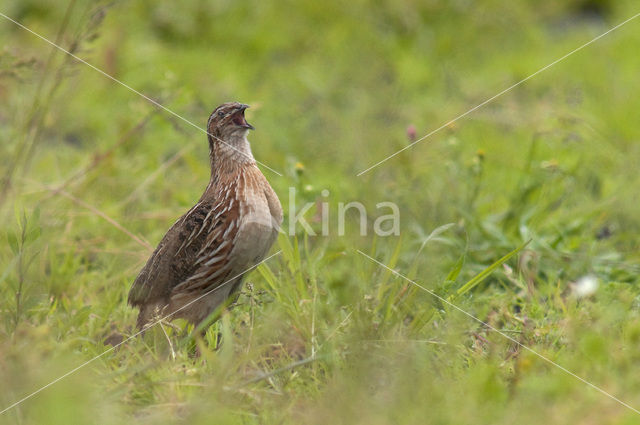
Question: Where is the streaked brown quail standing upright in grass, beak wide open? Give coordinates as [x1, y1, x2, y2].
[128, 102, 282, 330]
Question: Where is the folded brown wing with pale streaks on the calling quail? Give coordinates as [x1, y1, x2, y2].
[129, 197, 238, 306]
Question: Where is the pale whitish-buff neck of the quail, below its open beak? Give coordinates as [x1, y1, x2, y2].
[209, 133, 256, 186]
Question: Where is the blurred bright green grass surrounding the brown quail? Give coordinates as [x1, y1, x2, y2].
[0, 0, 640, 425]
